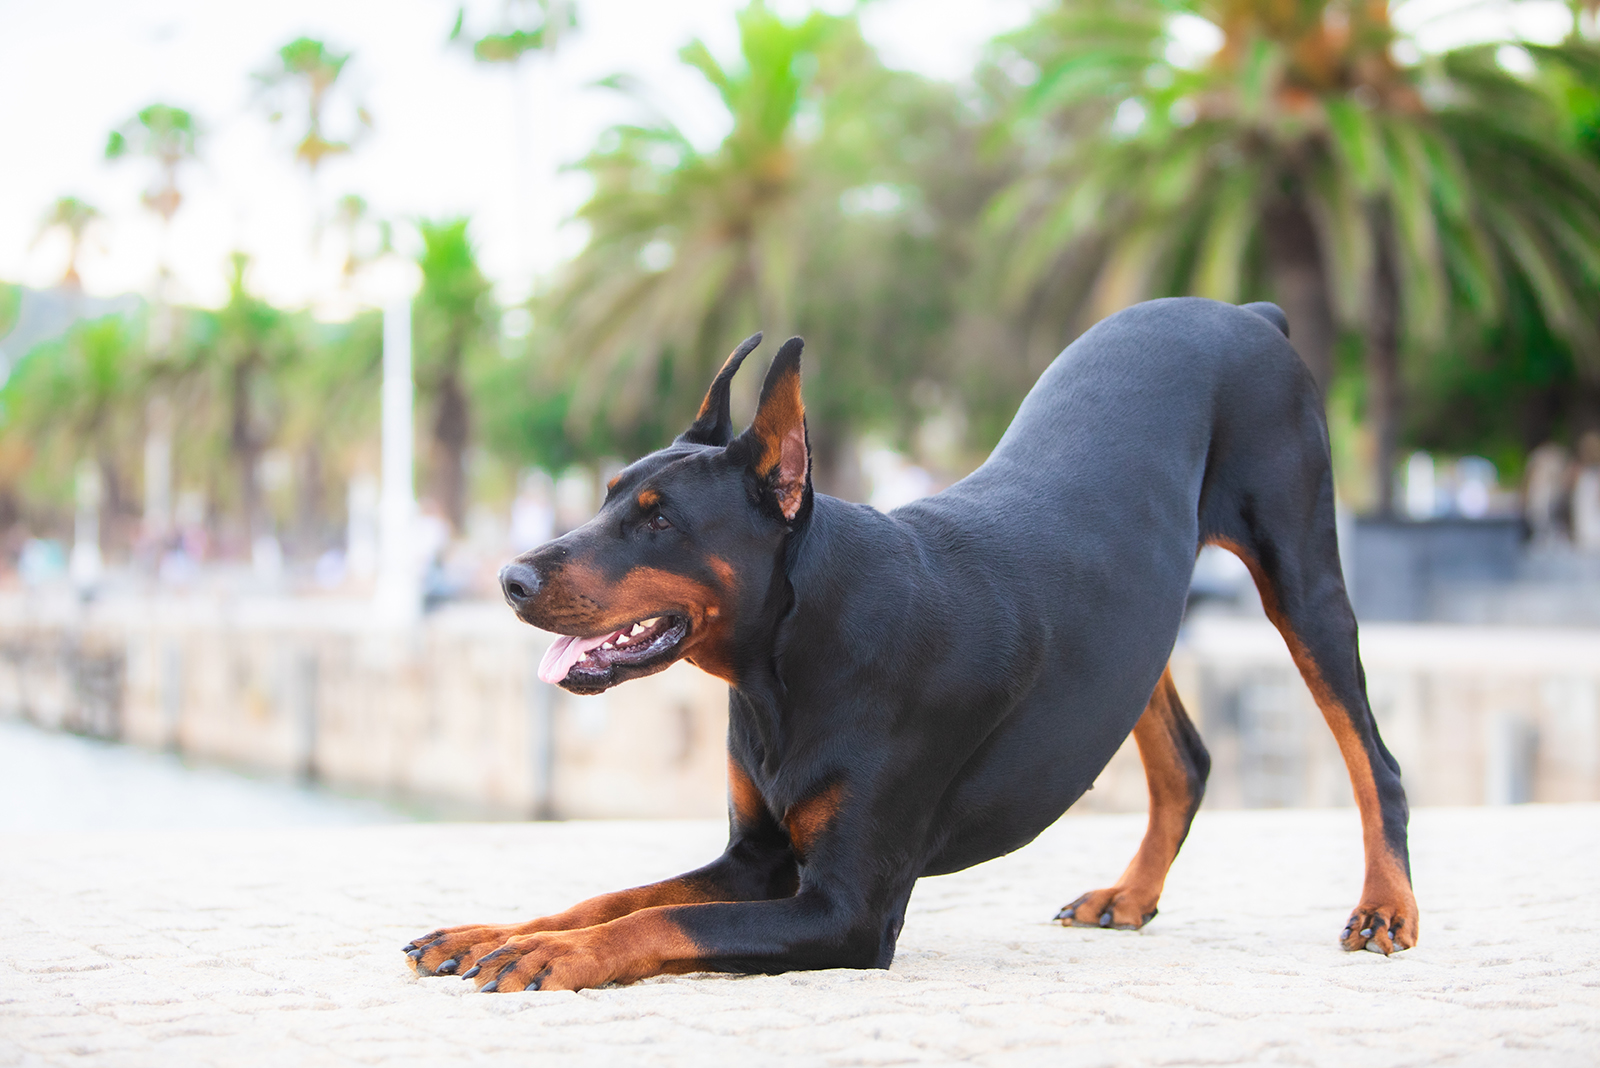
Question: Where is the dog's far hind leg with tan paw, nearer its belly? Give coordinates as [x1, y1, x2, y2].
[1056, 670, 1211, 931]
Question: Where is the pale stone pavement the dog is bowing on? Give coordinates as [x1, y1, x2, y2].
[0, 806, 1600, 1068]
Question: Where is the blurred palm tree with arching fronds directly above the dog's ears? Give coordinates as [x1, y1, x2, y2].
[550, 0, 842, 444]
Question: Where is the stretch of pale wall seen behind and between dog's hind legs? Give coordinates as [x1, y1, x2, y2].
[1078, 616, 1600, 811]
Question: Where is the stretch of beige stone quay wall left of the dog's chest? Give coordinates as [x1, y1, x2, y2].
[0, 598, 726, 817]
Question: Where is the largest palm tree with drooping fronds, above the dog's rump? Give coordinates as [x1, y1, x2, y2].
[994, 0, 1600, 512]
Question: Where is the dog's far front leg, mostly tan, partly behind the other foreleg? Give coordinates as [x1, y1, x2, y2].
[405, 835, 795, 977]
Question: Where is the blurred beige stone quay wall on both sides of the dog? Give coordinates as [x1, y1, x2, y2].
[0, 596, 1600, 817]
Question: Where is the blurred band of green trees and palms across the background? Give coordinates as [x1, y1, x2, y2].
[0, 0, 1600, 548]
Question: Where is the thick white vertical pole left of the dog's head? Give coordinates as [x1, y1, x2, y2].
[374, 297, 422, 624]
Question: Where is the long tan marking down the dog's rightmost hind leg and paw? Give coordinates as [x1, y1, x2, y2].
[1211, 537, 1418, 953]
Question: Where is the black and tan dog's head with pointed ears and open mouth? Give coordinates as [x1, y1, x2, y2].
[501, 334, 811, 694]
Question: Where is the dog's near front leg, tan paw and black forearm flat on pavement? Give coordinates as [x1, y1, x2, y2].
[477, 889, 909, 991]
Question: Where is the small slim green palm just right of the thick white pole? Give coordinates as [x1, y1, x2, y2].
[416, 219, 493, 531]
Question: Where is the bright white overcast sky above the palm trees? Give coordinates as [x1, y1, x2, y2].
[0, 0, 1566, 315]
